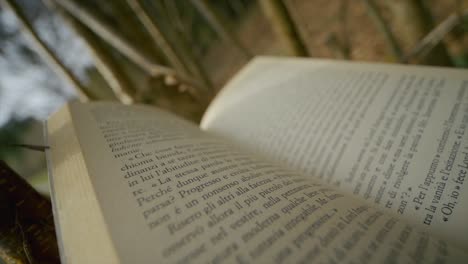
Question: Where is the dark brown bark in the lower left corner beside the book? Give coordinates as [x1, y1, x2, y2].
[0, 160, 60, 263]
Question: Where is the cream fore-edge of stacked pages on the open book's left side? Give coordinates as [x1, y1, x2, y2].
[47, 106, 118, 264]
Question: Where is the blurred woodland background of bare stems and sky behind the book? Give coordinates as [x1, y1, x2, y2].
[0, 0, 468, 195]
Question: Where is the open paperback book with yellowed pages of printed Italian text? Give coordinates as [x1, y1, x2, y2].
[47, 57, 468, 263]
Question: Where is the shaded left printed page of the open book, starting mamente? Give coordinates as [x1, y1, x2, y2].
[63, 103, 467, 263]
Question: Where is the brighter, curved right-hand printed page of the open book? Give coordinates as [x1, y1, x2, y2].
[201, 57, 468, 248]
